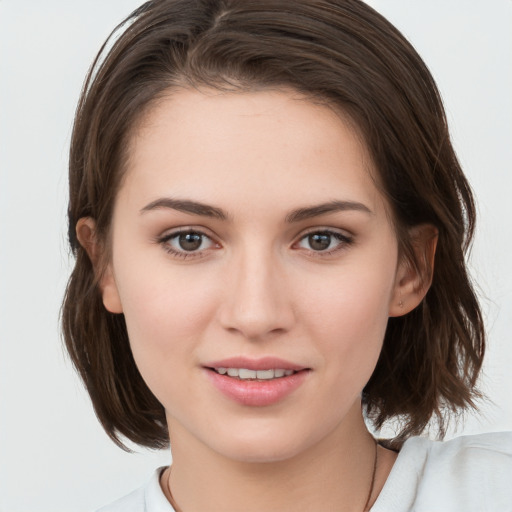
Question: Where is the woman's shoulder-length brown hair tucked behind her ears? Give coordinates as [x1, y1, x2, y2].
[62, 0, 485, 448]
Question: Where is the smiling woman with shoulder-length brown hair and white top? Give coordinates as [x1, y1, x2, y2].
[63, 0, 512, 512]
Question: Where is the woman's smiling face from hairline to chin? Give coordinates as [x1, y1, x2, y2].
[102, 90, 416, 461]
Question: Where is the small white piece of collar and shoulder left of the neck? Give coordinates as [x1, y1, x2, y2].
[96, 468, 174, 512]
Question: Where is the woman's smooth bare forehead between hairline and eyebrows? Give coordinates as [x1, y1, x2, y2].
[121, 89, 382, 217]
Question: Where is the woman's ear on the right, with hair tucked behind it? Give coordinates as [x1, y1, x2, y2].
[389, 224, 439, 316]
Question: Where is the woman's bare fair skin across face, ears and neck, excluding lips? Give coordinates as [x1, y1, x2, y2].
[77, 90, 433, 511]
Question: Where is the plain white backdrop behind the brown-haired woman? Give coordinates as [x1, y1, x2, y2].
[0, 0, 512, 512]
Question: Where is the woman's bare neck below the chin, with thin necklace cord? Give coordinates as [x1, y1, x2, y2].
[162, 408, 392, 512]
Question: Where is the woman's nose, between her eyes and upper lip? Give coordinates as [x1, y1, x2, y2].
[219, 250, 295, 340]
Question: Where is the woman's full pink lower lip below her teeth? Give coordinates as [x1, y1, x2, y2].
[206, 369, 309, 407]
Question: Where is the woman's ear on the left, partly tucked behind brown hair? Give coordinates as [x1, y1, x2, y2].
[76, 217, 123, 313]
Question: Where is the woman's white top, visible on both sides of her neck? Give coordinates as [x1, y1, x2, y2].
[97, 432, 512, 512]
